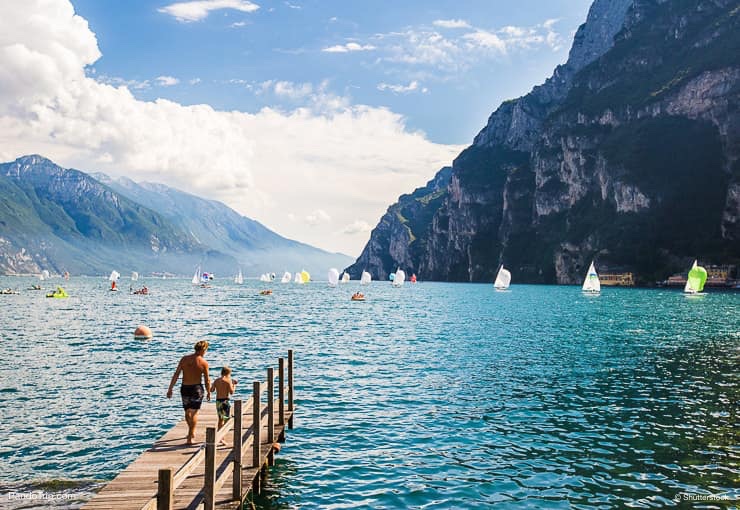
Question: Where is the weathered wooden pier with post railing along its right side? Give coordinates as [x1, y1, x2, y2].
[82, 351, 295, 510]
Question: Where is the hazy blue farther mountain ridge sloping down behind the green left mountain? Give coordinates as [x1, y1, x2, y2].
[93, 173, 351, 275]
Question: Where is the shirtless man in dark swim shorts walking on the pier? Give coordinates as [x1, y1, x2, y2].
[167, 340, 211, 445]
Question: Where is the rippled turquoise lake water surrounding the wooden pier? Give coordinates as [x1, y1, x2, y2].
[0, 277, 740, 508]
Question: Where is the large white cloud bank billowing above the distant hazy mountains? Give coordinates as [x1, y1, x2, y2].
[0, 0, 461, 255]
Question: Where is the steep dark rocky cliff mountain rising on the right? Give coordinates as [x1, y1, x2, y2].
[348, 0, 740, 283]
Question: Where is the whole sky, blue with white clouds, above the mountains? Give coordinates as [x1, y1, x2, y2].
[0, 0, 590, 256]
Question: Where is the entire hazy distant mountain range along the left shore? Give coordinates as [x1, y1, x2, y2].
[0, 155, 352, 276]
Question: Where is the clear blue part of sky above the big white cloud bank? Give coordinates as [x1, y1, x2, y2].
[73, 0, 590, 144]
